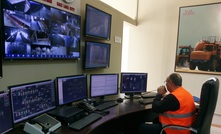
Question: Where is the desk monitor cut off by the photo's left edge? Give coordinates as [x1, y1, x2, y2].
[0, 92, 12, 134]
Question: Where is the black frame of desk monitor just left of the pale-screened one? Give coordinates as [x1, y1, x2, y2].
[56, 74, 88, 106]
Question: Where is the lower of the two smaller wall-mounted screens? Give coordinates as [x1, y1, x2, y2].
[84, 41, 111, 69]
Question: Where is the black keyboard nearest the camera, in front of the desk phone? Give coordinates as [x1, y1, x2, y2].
[69, 113, 102, 130]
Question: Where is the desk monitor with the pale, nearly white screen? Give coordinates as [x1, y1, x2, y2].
[90, 74, 119, 100]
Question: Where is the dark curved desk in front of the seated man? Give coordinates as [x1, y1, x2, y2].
[55, 99, 158, 134]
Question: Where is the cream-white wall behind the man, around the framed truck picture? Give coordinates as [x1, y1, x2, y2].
[127, 0, 221, 124]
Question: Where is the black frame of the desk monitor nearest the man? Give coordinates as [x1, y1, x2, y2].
[120, 72, 148, 95]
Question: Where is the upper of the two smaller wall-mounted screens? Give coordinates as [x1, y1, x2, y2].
[85, 4, 112, 40]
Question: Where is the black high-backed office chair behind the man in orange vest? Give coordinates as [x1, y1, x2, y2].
[160, 77, 219, 134]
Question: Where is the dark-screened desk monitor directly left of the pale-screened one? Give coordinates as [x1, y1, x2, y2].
[57, 74, 87, 106]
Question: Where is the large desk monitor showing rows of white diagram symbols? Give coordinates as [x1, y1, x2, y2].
[9, 80, 56, 124]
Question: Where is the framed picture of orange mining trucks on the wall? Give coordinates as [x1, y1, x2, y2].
[175, 3, 221, 74]
